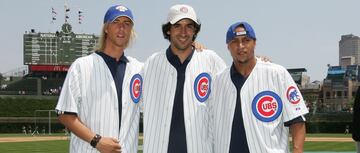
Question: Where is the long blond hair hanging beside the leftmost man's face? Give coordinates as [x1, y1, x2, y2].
[97, 23, 137, 52]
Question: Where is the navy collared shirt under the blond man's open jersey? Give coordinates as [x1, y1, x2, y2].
[96, 51, 129, 129]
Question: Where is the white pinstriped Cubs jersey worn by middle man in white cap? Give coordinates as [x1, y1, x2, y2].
[142, 50, 226, 153]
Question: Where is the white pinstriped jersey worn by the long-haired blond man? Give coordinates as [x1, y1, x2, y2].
[56, 53, 143, 153]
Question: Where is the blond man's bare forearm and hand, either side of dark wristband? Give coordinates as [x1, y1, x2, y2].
[58, 114, 121, 153]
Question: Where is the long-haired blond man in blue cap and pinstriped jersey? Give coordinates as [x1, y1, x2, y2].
[56, 5, 143, 153]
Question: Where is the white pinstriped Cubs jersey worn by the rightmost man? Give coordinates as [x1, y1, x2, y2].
[209, 60, 308, 153]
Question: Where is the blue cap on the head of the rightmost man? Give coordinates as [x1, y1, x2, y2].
[226, 22, 256, 44]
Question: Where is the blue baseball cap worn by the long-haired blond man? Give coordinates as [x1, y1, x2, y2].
[104, 5, 134, 23]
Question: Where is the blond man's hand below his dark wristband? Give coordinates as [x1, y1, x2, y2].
[96, 137, 121, 153]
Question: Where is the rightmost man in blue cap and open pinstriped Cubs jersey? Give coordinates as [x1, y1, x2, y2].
[209, 22, 308, 153]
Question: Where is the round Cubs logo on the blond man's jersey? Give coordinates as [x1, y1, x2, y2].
[130, 74, 142, 103]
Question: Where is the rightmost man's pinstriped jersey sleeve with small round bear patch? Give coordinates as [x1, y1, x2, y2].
[281, 68, 309, 122]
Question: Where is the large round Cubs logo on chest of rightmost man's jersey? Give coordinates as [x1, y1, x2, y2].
[251, 91, 283, 122]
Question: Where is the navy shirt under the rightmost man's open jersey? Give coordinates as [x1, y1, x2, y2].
[229, 63, 249, 153]
